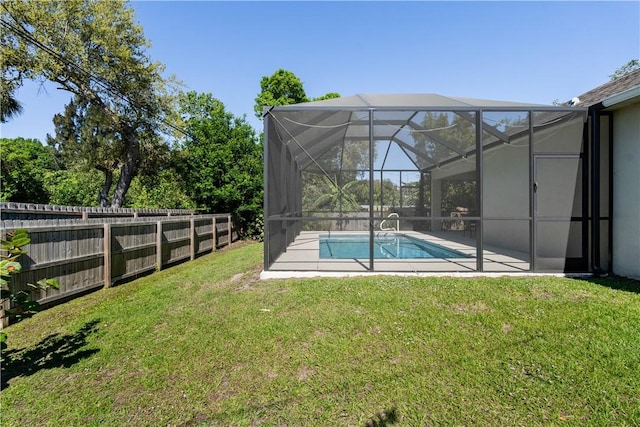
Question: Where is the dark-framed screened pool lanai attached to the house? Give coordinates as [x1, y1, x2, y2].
[264, 94, 588, 272]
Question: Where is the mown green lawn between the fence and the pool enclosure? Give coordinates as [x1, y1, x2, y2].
[1, 244, 640, 426]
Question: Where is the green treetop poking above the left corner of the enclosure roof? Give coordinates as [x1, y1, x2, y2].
[253, 69, 308, 119]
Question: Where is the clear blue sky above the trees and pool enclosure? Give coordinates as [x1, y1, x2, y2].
[0, 1, 640, 143]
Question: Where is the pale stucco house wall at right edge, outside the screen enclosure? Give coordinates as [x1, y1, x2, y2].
[613, 103, 640, 279]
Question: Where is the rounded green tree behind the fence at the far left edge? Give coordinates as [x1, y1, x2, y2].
[0, 138, 56, 203]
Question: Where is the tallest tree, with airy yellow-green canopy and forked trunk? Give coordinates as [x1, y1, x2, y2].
[1, 0, 176, 207]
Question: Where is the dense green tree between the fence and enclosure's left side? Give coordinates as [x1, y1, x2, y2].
[179, 92, 263, 237]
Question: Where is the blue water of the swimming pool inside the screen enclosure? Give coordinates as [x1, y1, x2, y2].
[320, 233, 469, 259]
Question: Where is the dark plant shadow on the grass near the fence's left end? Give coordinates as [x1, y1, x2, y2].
[0, 320, 100, 390]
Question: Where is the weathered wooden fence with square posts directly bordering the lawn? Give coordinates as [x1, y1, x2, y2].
[0, 214, 238, 326]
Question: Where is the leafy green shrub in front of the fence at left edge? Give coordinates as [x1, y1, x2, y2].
[0, 229, 60, 349]
